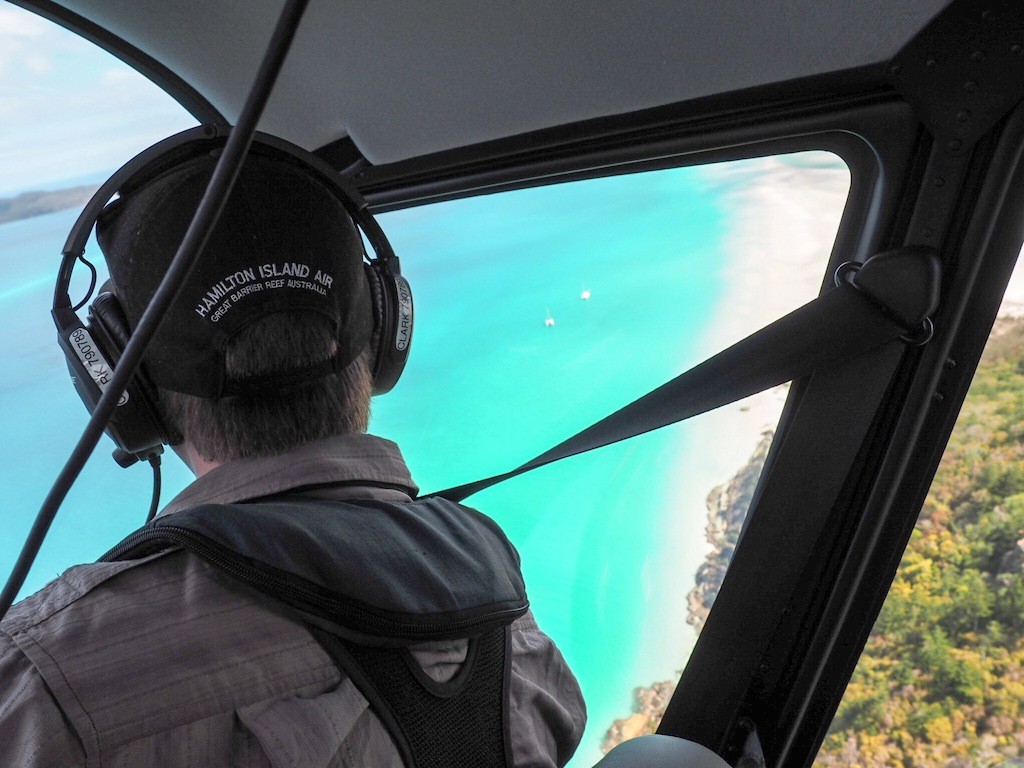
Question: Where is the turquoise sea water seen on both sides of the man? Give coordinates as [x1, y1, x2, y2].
[0, 169, 725, 765]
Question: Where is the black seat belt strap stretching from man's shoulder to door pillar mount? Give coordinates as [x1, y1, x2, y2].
[431, 246, 940, 502]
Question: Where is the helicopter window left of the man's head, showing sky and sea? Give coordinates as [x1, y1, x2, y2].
[0, 3, 196, 597]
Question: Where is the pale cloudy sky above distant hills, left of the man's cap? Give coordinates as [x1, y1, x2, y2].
[0, 0, 196, 197]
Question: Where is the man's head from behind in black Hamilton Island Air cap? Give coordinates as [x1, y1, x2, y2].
[96, 147, 374, 463]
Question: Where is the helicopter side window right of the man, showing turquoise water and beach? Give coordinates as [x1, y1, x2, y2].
[371, 152, 850, 765]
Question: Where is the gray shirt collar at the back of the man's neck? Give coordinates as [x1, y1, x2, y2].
[159, 434, 419, 516]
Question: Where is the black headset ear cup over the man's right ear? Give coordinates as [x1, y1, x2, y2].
[366, 261, 413, 394]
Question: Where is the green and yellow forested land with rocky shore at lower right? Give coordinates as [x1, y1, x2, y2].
[604, 319, 1024, 768]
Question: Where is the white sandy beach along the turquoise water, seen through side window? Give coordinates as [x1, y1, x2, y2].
[663, 158, 849, 679]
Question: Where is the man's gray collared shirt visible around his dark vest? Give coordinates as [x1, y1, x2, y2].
[0, 435, 586, 768]
